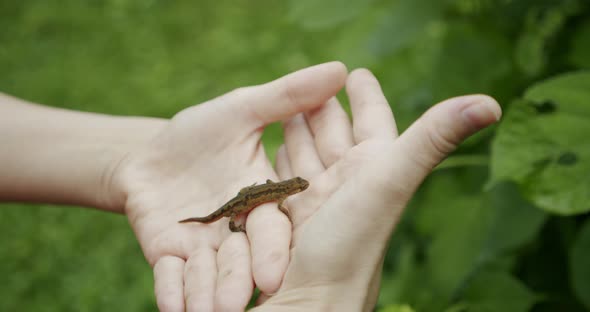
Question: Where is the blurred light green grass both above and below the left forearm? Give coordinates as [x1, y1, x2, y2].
[0, 0, 310, 311]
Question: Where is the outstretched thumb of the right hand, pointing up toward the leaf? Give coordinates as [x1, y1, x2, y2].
[320, 95, 502, 246]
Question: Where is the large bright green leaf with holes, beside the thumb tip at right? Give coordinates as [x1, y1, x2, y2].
[491, 72, 590, 215]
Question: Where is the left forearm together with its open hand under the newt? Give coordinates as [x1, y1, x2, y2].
[0, 62, 347, 311]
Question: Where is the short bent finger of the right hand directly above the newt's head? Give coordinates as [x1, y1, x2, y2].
[283, 114, 324, 178]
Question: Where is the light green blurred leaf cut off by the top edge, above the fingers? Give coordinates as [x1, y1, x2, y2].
[289, 0, 374, 30]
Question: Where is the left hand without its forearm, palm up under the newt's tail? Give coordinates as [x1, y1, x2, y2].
[113, 62, 347, 311]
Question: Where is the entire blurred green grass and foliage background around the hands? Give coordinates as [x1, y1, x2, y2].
[0, 0, 590, 312]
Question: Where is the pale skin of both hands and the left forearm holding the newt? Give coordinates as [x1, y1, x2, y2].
[0, 62, 500, 311]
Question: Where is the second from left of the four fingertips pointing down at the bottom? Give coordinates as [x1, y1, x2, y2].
[184, 247, 217, 312]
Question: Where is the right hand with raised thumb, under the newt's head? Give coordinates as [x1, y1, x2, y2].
[255, 70, 501, 311]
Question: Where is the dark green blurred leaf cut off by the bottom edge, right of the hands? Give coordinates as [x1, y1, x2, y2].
[462, 272, 536, 312]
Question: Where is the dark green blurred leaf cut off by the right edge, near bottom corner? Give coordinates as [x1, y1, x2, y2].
[570, 220, 590, 309]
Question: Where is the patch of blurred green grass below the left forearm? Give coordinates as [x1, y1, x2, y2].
[0, 205, 153, 311]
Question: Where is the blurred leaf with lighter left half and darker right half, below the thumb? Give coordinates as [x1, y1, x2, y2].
[428, 185, 545, 299]
